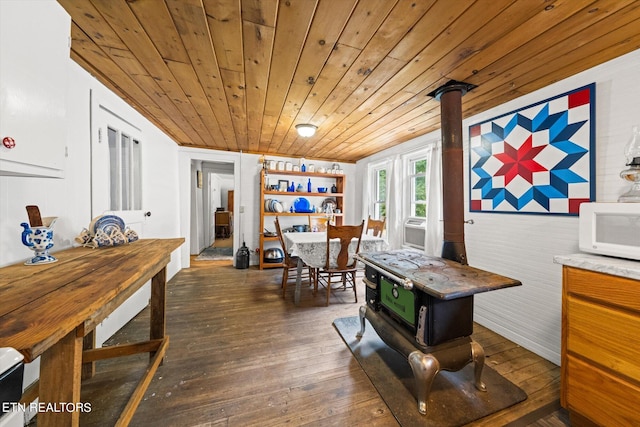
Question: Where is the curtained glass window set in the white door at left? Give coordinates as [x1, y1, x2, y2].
[107, 126, 142, 211]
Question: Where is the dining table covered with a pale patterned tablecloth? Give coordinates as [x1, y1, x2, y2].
[283, 231, 388, 305]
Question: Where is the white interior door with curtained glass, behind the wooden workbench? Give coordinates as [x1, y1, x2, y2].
[91, 100, 151, 347]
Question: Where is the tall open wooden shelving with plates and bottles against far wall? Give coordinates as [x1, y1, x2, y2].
[258, 169, 346, 270]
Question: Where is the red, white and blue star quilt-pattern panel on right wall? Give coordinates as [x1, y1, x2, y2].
[469, 83, 595, 215]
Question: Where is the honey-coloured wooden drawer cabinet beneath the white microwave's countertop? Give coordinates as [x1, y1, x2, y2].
[561, 265, 640, 425]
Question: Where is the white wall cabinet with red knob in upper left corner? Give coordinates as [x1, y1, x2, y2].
[0, 0, 71, 178]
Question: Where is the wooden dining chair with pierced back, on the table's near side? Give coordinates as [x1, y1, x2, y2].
[314, 220, 364, 306]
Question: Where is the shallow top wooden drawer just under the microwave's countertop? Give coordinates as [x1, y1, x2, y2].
[563, 266, 640, 312]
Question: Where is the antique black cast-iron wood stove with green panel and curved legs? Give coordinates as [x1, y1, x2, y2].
[357, 250, 521, 414]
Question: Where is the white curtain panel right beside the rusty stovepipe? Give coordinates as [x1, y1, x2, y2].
[424, 142, 444, 257]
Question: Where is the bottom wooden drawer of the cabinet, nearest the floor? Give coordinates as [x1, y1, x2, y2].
[566, 356, 640, 426]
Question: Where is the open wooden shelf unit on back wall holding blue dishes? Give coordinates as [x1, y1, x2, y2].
[259, 170, 346, 269]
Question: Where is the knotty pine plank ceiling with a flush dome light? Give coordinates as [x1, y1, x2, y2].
[58, 0, 640, 162]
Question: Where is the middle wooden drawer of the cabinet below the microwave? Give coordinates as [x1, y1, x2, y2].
[566, 296, 640, 383]
